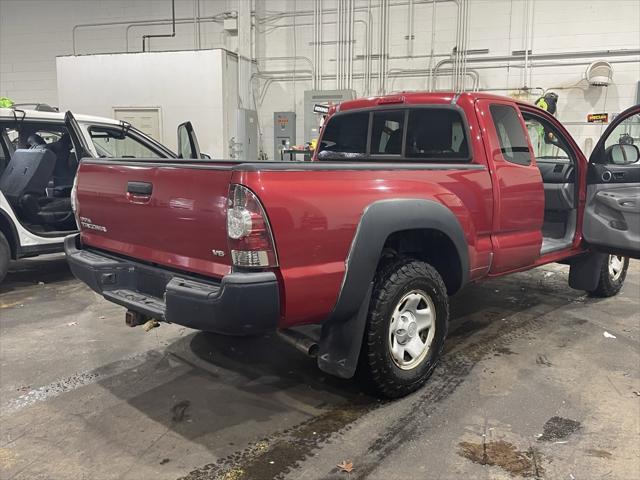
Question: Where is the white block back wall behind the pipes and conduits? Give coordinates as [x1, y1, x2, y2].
[0, 0, 640, 158]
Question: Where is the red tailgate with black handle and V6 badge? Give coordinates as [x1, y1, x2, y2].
[77, 159, 232, 277]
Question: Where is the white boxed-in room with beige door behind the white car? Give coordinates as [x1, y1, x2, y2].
[57, 50, 237, 158]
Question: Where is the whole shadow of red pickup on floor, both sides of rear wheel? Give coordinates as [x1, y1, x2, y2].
[99, 264, 584, 458]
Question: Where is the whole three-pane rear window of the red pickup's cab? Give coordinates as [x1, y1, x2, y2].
[318, 106, 470, 163]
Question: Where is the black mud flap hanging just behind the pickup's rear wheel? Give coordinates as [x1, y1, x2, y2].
[318, 282, 373, 378]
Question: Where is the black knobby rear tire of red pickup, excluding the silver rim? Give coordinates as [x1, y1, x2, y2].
[358, 258, 449, 398]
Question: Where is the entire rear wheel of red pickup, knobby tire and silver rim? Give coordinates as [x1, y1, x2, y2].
[359, 259, 449, 398]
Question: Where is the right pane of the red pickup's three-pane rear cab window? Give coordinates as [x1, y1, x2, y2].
[405, 108, 469, 161]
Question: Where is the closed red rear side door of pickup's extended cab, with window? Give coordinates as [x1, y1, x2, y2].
[476, 99, 544, 275]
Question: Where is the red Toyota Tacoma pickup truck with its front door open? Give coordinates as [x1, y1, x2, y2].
[65, 93, 640, 397]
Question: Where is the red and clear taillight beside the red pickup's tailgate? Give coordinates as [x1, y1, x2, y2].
[227, 185, 278, 268]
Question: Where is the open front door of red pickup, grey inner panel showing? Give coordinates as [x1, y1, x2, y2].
[582, 104, 640, 258]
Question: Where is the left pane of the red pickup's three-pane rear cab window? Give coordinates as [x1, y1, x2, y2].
[318, 112, 369, 156]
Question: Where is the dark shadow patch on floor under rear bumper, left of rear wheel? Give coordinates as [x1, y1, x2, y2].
[94, 332, 364, 455]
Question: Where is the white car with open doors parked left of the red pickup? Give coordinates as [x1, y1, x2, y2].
[0, 104, 200, 282]
